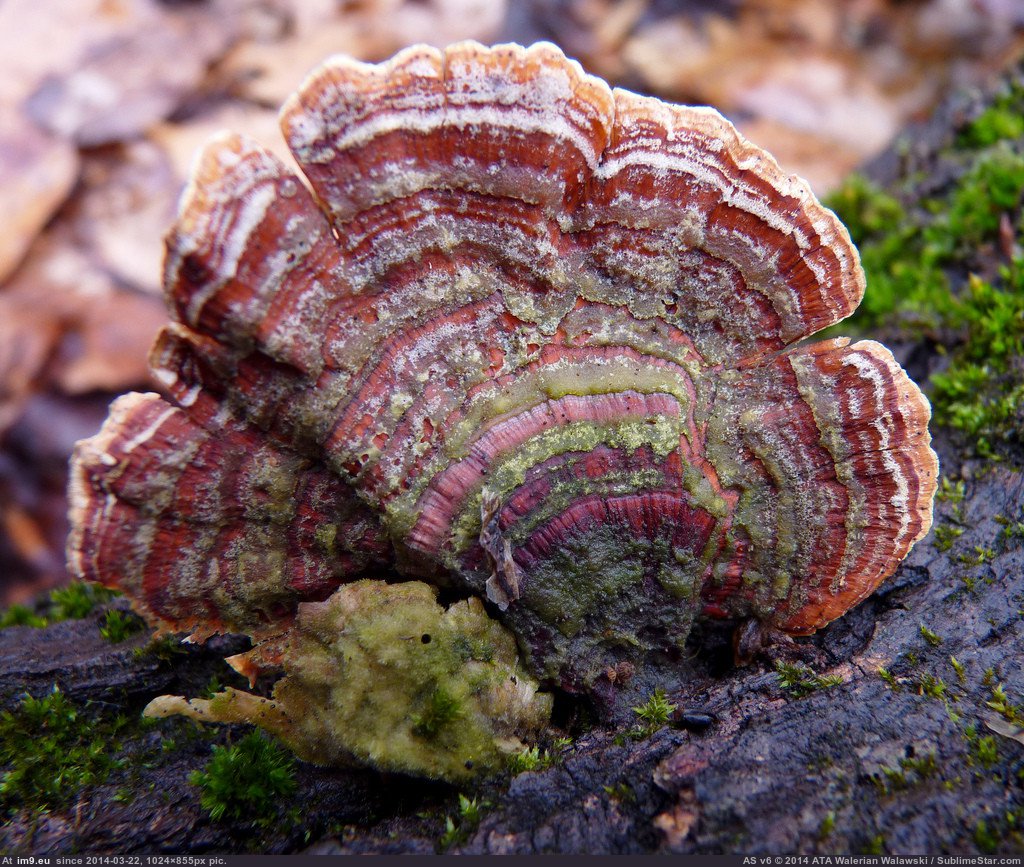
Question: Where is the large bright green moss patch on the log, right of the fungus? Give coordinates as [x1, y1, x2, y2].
[828, 109, 1024, 464]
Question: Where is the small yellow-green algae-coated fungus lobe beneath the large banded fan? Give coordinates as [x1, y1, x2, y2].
[145, 580, 551, 780]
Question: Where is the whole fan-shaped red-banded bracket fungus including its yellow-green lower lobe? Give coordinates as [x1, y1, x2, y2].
[69, 43, 937, 777]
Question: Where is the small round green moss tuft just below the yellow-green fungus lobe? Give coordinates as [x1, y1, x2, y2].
[188, 732, 296, 823]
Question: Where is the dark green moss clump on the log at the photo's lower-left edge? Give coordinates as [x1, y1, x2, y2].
[0, 686, 129, 812]
